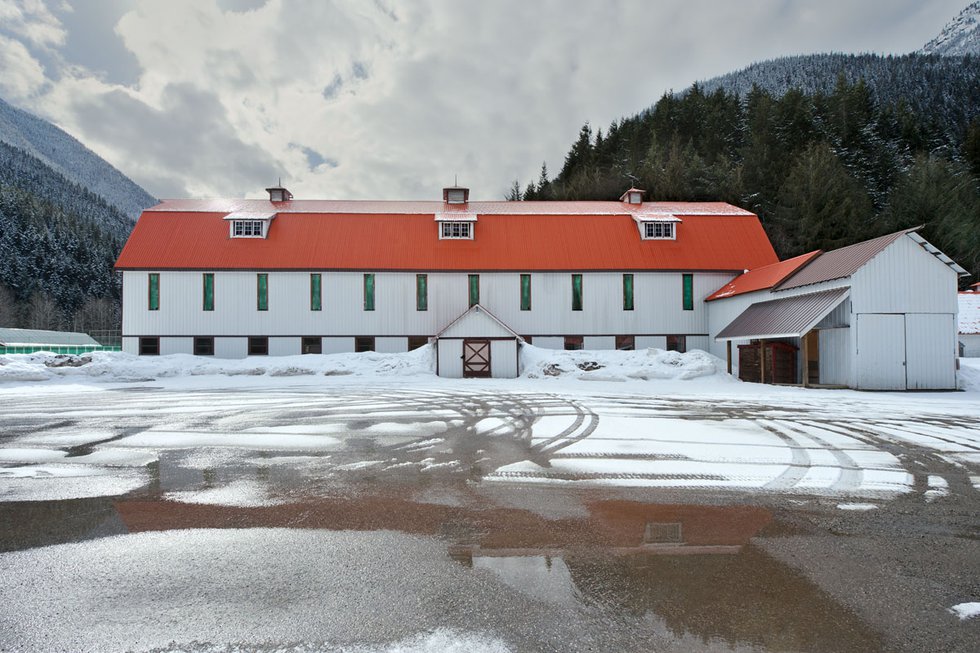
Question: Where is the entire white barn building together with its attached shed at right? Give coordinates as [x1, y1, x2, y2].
[116, 187, 965, 390]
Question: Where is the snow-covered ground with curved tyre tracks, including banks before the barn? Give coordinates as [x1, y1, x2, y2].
[0, 347, 980, 502]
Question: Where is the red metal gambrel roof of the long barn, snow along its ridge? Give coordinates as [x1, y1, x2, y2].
[116, 200, 777, 271]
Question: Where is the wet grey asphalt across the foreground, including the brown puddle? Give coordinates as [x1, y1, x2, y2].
[0, 384, 980, 652]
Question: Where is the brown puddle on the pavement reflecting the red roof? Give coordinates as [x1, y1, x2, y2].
[0, 486, 884, 652]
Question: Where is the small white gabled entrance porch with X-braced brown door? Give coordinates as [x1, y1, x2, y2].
[435, 304, 521, 379]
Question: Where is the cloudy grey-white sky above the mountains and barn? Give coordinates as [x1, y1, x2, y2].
[0, 0, 968, 199]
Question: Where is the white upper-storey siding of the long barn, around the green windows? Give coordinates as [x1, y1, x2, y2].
[123, 271, 732, 342]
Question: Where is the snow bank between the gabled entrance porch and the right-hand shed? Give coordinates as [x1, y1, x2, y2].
[521, 345, 733, 381]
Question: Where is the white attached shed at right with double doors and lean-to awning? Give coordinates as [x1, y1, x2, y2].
[708, 229, 966, 390]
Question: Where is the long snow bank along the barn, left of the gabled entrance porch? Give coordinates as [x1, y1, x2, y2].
[0, 345, 435, 383]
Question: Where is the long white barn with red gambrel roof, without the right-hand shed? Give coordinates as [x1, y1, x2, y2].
[116, 187, 777, 376]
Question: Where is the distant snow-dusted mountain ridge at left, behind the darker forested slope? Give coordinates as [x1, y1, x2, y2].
[0, 99, 157, 221]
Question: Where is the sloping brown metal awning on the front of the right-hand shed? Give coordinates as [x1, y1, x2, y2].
[715, 288, 850, 340]
